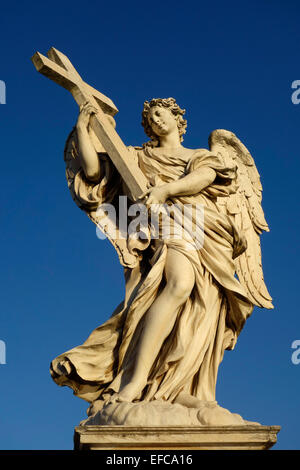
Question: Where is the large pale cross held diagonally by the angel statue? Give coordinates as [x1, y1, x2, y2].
[32, 47, 147, 199]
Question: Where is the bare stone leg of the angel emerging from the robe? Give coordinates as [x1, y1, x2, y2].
[111, 248, 195, 401]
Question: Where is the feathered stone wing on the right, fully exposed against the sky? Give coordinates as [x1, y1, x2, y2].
[209, 129, 274, 309]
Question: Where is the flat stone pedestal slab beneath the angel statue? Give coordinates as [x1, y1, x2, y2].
[74, 425, 280, 450]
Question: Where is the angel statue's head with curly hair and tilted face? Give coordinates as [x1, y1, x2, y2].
[142, 98, 187, 147]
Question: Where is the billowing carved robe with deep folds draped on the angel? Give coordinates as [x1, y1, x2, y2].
[51, 147, 253, 402]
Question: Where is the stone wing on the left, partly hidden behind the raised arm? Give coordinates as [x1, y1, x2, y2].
[64, 128, 139, 268]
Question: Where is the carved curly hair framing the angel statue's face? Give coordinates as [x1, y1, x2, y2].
[141, 98, 187, 147]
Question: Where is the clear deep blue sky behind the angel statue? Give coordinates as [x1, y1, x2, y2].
[0, 0, 300, 449]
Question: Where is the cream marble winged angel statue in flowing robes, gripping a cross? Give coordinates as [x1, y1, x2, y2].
[51, 98, 273, 424]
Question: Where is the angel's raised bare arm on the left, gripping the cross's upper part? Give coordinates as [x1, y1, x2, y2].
[76, 103, 100, 183]
